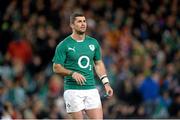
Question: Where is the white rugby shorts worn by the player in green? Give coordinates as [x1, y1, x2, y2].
[64, 89, 101, 113]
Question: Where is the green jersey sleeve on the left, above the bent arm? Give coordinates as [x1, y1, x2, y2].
[52, 42, 66, 65]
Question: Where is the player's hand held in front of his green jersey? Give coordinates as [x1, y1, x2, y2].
[72, 72, 86, 85]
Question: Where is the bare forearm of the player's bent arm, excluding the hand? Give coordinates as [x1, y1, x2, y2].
[53, 63, 73, 76]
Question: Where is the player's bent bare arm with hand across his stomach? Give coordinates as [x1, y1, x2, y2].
[53, 63, 86, 85]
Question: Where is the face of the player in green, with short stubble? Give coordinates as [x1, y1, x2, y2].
[71, 16, 87, 34]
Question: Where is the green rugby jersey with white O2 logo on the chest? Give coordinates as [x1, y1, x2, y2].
[52, 35, 101, 90]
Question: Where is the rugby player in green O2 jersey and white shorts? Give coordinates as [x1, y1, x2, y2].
[52, 13, 113, 119]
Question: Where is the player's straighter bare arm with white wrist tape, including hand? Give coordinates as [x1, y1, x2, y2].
[95, 60, 113, 97]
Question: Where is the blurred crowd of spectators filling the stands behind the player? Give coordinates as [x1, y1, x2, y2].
[0, 0, 180, 119]
